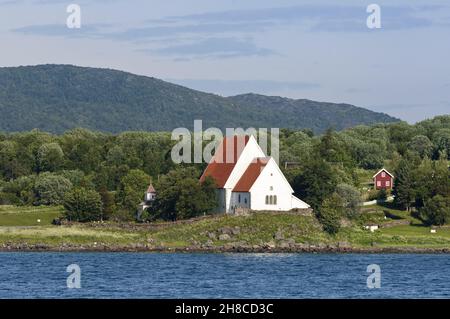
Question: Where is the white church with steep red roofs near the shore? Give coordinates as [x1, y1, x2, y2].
[200, 136, 310, 213]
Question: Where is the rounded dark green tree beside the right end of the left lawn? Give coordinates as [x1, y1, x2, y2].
[63, 188, 102, 222]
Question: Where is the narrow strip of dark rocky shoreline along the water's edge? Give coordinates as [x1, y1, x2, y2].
[0, 243, 450, 254]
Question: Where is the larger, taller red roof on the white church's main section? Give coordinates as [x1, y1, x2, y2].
[200, 135, 250, 188]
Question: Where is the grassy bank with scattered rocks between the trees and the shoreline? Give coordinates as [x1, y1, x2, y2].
[0, 206, 450, 250]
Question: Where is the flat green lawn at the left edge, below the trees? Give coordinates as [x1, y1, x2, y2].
[0, 205, 62, 226]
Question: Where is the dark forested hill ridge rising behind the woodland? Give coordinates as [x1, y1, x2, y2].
[0, 65, 397, 133]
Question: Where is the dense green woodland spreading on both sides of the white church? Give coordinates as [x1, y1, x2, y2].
[0, 115, 450, 233]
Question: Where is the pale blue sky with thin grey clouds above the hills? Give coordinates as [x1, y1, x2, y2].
[0, 0, 450, 123]
